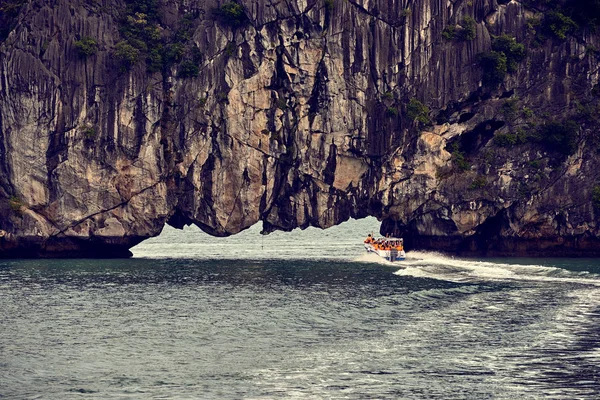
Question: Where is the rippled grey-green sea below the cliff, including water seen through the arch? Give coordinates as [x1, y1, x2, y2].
[0, 219, 600, 399]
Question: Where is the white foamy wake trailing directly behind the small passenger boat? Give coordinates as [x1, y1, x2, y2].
[395, 251, 600, 286]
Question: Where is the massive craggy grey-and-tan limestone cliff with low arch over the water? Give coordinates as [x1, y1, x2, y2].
[0, 0, 600, 257]
